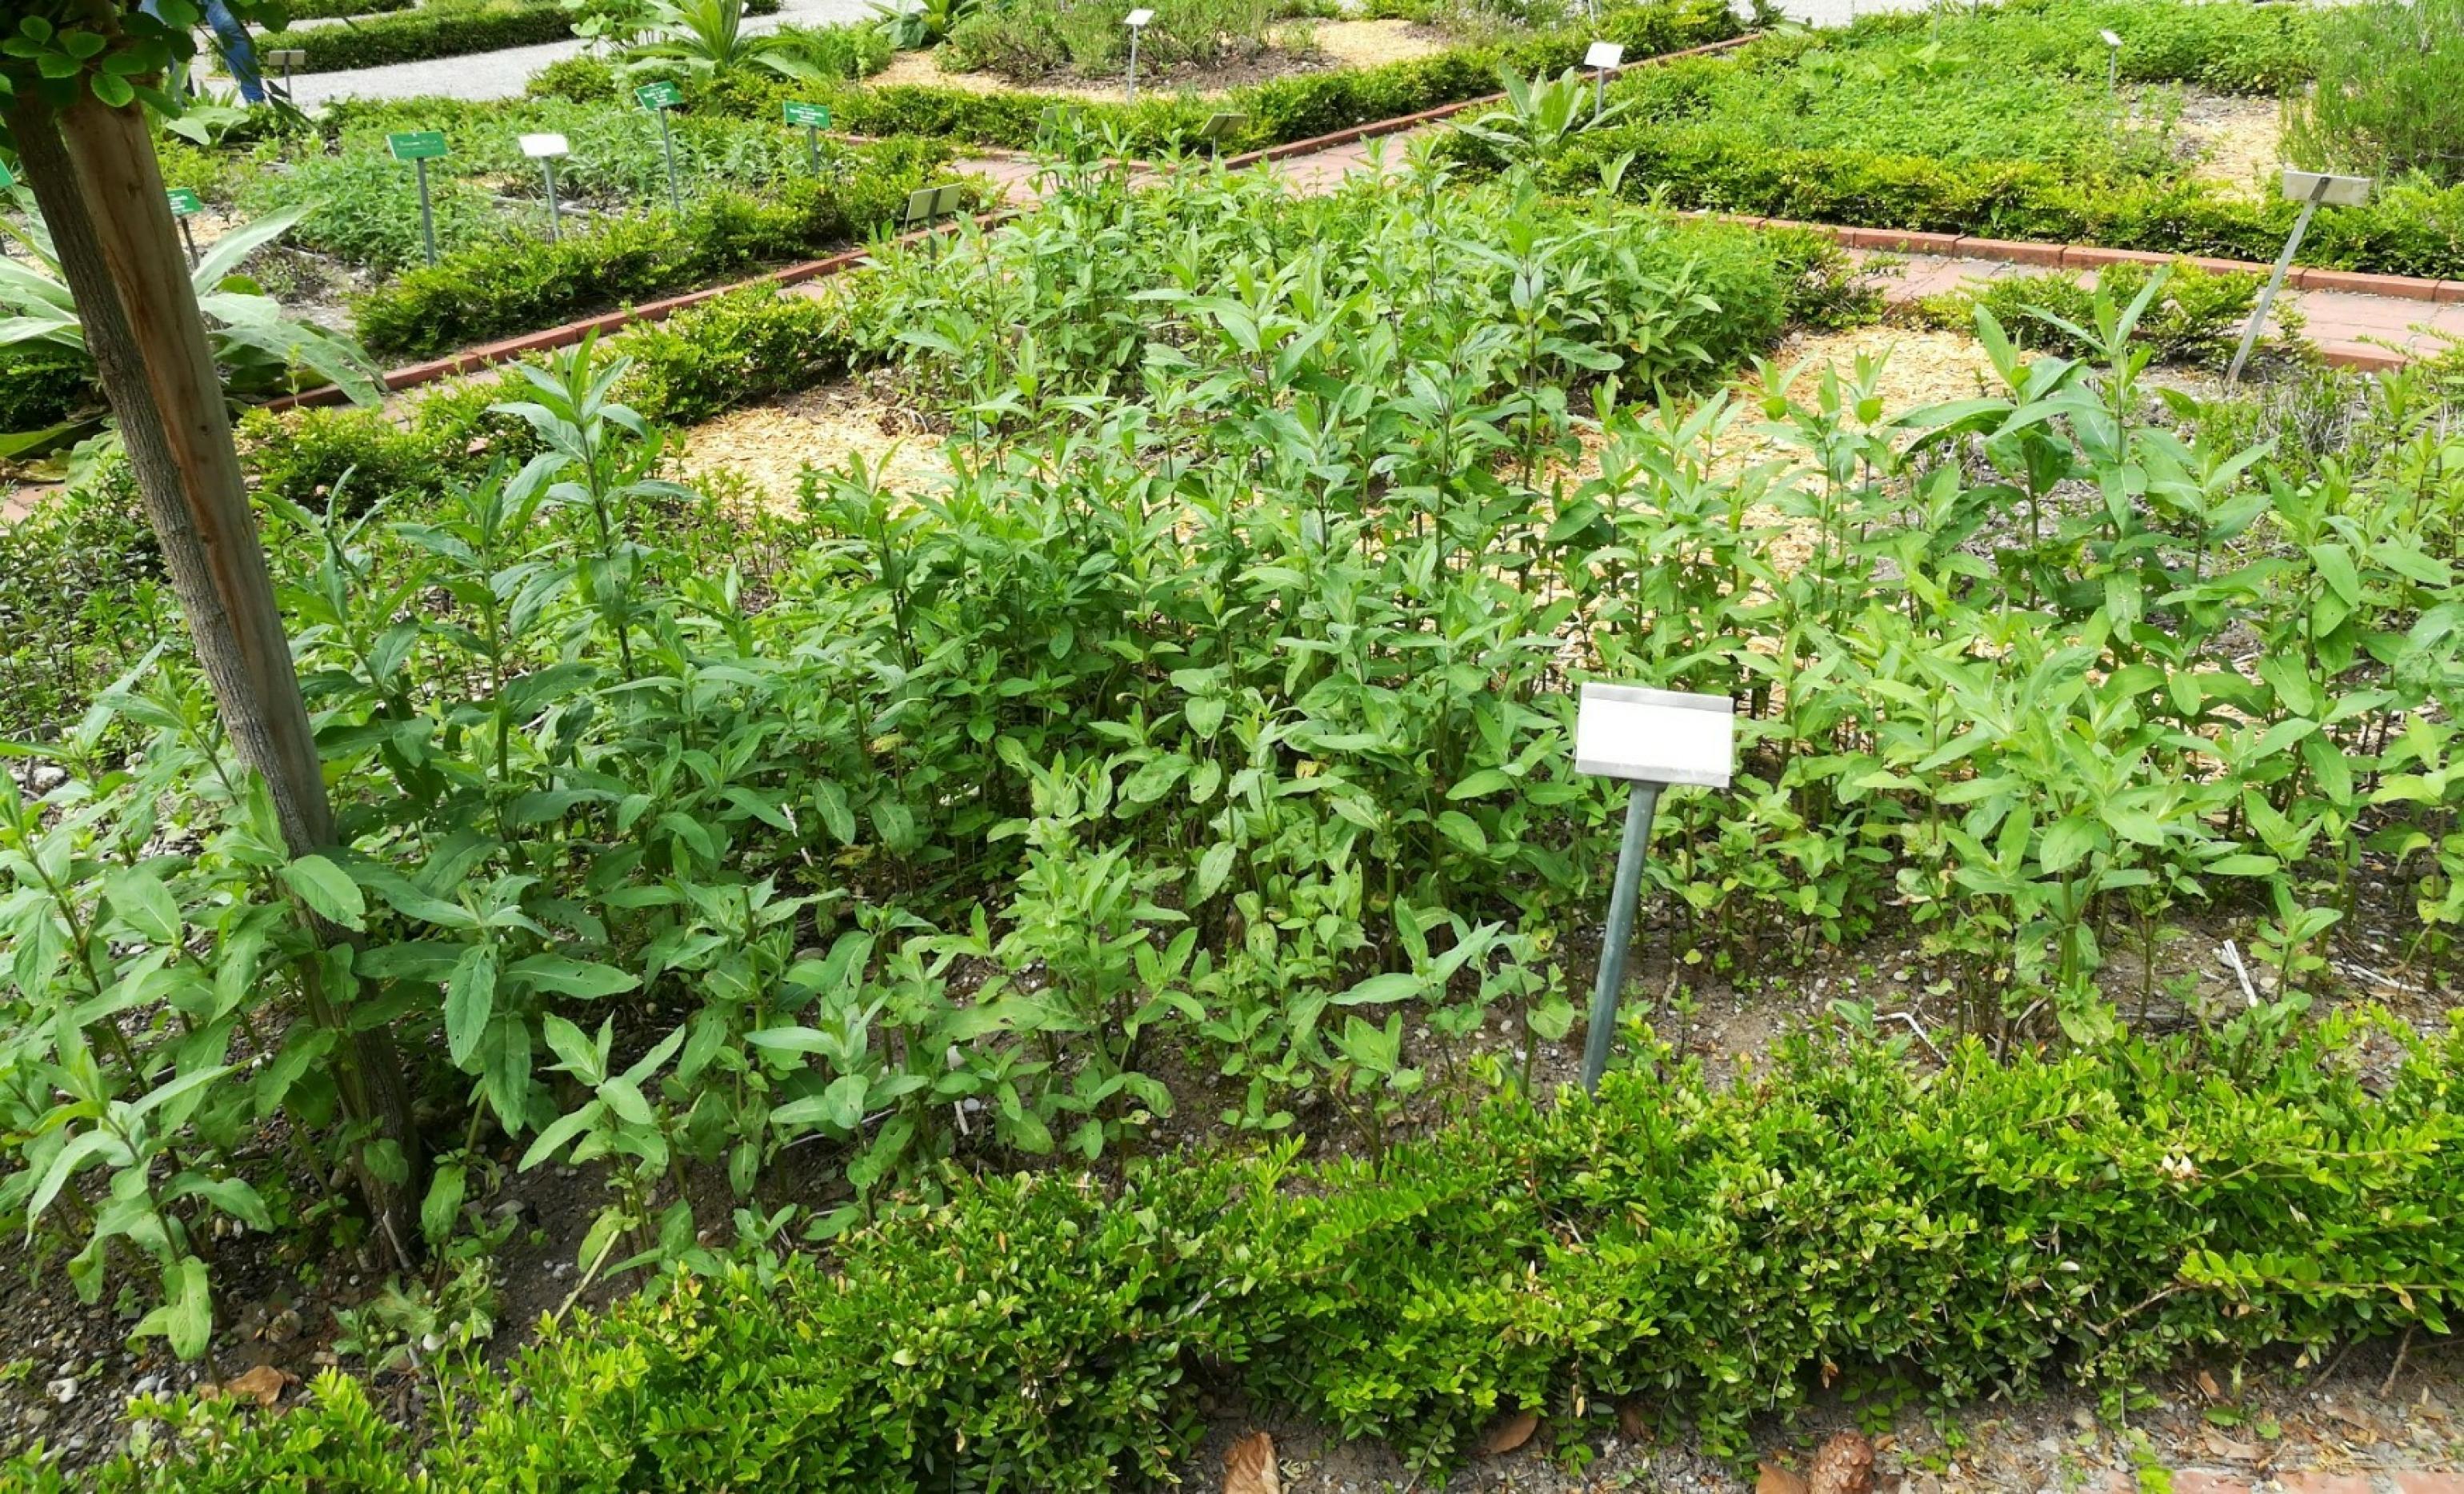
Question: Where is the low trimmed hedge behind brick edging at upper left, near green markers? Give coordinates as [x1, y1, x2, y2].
[355, 141, 949, 358]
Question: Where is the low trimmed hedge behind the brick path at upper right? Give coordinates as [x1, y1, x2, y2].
[1552, 123, 2464, 278]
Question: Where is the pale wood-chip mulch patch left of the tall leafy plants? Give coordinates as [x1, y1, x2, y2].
[675, 382, 949, 510]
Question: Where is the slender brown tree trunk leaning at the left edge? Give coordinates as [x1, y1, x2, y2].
[7, 91, 419, 1260]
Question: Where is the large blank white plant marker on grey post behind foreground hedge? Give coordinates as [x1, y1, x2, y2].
[1574, 685, 1737, 1095]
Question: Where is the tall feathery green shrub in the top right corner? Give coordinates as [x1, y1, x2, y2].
[2284, 0, 2464, 187]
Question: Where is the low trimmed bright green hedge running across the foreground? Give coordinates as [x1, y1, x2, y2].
[53, 1013, 2464, 1494]
